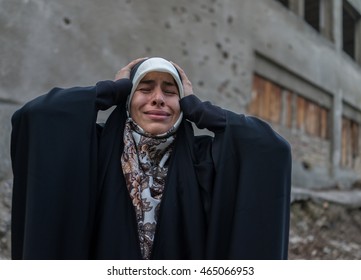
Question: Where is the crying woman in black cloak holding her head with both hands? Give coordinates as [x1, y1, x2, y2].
[11, 58, 291, 259]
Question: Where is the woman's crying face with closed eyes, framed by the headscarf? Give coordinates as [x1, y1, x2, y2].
[130, 72, 180, 135]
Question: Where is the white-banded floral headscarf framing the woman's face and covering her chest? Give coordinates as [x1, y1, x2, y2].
[121, 57, 184, 259]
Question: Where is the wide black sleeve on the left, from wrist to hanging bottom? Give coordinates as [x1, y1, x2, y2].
[11, 80, 131, 259]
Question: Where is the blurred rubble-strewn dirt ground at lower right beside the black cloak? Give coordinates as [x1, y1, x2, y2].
[288, 200, 361, 260]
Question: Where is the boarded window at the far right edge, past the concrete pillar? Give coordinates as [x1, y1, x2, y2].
[341, 117, 360, 168]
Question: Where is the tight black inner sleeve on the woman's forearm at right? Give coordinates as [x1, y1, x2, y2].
[180, 94, 226, 132]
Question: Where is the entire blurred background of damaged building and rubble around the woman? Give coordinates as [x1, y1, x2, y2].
[0, 0, 361, 259]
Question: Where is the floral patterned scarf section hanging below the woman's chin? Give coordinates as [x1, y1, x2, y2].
[121, 118, 175, 259]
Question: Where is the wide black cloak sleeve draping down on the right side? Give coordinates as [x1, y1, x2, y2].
[207, 111, 292, 260]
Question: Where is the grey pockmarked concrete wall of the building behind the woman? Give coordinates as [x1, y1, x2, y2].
[0, 0, 361, 258]
